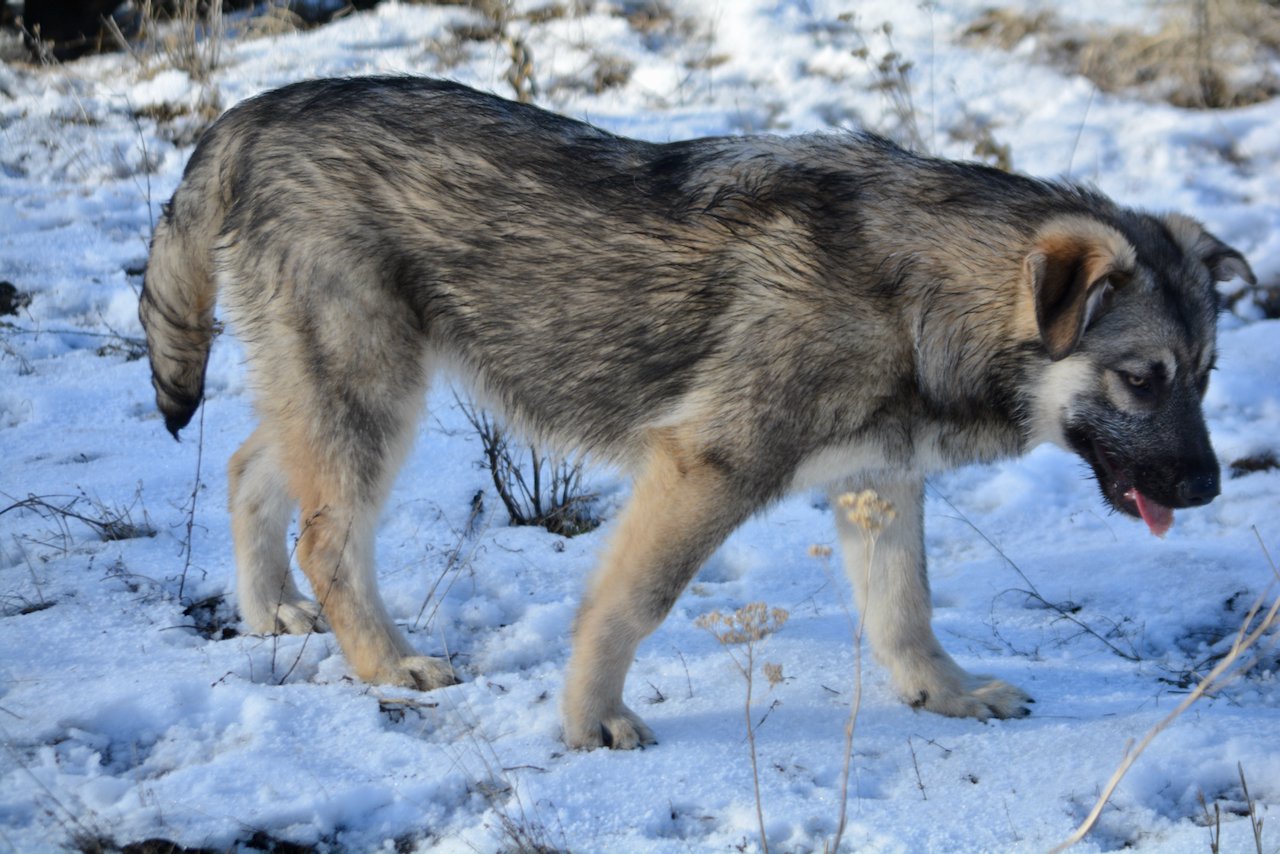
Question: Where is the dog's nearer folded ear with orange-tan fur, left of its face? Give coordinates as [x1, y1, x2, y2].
[1024, 216, 1137, 361]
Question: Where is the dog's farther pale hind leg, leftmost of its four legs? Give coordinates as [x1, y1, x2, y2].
[227, 426, 326, 634]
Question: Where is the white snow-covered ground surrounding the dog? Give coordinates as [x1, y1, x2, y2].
[0, 0, 1280, 851]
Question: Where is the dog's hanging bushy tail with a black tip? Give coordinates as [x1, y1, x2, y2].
[138, 135, 229, 439]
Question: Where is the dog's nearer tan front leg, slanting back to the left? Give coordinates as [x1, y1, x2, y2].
[563, 437, 753, 749]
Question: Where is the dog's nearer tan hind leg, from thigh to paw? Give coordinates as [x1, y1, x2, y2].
[246, 302, 457, 690]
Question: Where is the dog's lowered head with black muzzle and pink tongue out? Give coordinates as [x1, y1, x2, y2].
[1024, 211, 1254, 535]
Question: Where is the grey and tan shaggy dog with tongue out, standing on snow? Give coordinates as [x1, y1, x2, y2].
[140, 77, 1254, 749]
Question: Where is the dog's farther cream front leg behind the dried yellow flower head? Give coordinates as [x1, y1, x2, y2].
[831, 476, 1030, 721]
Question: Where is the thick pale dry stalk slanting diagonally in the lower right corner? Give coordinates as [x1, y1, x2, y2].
[1050, 529, 1280, 854]
